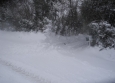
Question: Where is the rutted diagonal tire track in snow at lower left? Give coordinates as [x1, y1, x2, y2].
[0, 58, 52, 83]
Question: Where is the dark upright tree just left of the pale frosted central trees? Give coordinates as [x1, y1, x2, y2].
[33, 0, 49, 30]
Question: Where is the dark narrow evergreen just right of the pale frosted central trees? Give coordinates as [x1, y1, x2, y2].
[66, 0, 82, 34]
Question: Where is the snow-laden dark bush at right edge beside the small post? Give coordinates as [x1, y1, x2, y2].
[89, 21, 115, 48]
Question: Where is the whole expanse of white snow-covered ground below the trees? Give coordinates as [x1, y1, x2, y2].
[0, 31, 115, 83]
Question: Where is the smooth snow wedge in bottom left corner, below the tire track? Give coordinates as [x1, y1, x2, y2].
[0, 64, 31, 83]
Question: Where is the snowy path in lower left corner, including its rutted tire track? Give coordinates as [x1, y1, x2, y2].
[0, 59, 50, 83]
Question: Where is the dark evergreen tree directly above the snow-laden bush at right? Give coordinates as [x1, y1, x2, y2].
[81, 0, 115, 25]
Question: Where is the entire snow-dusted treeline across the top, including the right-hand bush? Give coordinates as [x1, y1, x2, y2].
[0, 0, 115, 48]
